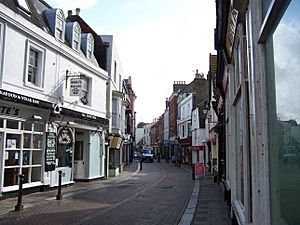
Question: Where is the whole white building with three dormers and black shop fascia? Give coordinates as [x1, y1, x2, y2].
[0, 0, 109, 193]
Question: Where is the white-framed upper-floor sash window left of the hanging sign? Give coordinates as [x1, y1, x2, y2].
[25, 41, 45, 87]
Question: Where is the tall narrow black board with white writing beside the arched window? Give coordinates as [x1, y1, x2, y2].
[45, 132, 56, 171]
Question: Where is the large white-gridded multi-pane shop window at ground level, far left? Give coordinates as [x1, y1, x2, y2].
[1, 119, 45, 190]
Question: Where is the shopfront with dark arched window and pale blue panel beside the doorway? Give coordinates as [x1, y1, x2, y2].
[50, 109, 107, 186]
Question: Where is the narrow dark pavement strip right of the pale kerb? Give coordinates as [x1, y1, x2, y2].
[191, 176, 231, 225]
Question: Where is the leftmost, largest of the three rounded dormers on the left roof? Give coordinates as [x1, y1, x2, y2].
[45, 9, 65, 42]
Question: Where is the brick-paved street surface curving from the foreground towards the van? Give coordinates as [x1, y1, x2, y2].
[0, 162, 193, 225]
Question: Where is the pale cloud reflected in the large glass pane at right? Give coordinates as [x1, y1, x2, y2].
[273, 22, 300, 123]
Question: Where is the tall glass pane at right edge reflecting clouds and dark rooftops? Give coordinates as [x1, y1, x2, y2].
[267, 1, 300, 225]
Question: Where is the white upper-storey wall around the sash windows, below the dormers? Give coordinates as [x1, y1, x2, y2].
[0, 4, 108, 118]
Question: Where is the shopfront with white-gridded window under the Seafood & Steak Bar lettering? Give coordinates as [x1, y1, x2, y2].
[0, 90, 51, 193]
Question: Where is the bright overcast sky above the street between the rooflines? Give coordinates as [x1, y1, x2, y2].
[46, 0, 216, 122]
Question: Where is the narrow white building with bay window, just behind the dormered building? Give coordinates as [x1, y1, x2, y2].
[101, 35, 125, 176]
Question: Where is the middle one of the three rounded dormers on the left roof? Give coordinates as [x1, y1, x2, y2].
[66, 22, 81, 51]
